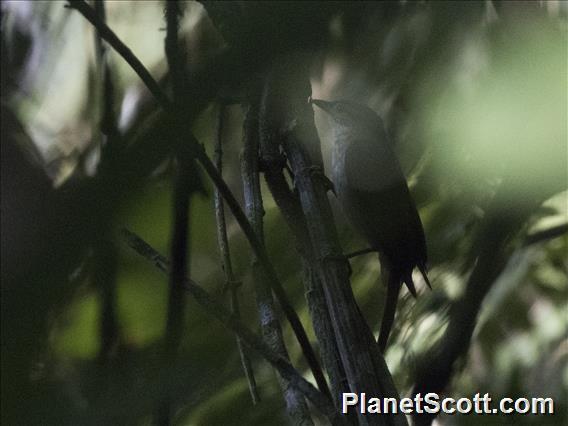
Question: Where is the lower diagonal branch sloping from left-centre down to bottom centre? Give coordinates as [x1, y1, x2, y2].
[122, 229, 345, 425]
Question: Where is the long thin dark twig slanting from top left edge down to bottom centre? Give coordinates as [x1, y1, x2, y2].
[69, 0, 325, 400]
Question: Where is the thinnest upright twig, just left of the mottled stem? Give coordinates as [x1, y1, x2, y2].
[213, 104, 260, 404]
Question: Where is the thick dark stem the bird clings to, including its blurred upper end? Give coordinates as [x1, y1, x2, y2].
[264, 56, 406, 425]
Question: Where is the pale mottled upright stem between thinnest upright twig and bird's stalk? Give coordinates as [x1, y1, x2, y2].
[241, 100, 313, 425]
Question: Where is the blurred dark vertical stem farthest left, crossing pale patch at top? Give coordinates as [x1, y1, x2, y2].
[94, 0, 120, 362]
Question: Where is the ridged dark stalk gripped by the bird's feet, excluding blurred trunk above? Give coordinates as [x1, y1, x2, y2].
[285, 135, 406, 425]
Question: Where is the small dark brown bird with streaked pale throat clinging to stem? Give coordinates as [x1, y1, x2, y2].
[310, 99, 430, 352]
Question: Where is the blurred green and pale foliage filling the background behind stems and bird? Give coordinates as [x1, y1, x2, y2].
[2, 1, 568, 425]
